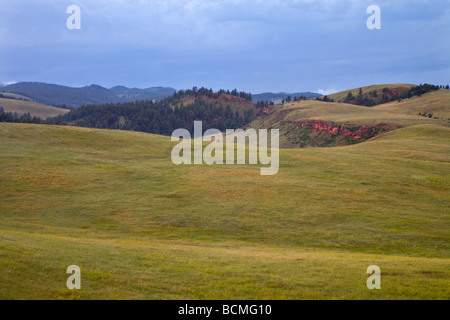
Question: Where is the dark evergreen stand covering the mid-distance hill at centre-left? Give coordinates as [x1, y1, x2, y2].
[59, 87, 257, 135]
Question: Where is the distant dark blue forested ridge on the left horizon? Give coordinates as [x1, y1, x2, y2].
[1, 82, 175, 107]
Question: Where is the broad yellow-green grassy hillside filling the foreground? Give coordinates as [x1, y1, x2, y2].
[0, 123, 450, 299]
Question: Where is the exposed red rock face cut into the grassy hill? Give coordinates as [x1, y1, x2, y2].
[282, 120, 388, 139]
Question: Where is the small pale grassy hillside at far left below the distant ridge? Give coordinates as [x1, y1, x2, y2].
[0, 98, 69, 119]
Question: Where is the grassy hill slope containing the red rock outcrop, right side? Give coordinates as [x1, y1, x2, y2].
[248, 85, 450, 148]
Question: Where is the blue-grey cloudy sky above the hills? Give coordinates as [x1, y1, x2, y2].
[0, 0, 450, 93]
